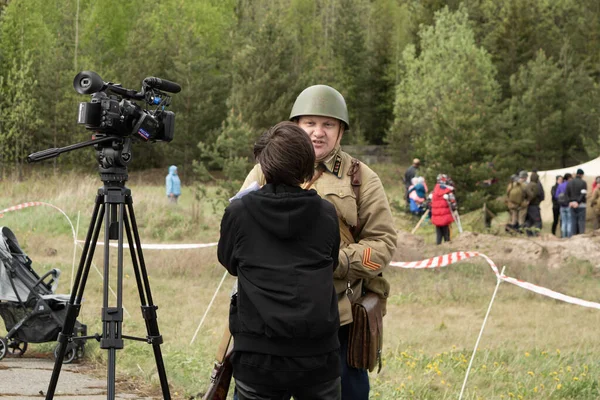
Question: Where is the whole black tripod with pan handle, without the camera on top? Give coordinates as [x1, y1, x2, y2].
[27, 136, 171, 400]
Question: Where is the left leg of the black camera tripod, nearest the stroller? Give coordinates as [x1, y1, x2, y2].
[46, 196, 104, 400]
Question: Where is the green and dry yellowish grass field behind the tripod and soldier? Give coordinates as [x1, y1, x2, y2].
[0, 170, 600, 400]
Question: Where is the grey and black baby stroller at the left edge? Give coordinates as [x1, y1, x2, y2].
[0, 227, 87, 363]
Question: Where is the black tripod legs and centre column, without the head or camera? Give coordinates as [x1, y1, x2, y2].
[46, 179, 171, 400]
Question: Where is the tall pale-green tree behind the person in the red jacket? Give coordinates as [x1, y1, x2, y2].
[388, 7, 499, 209]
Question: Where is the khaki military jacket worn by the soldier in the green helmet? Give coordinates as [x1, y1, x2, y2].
[242, 147, 397, 325]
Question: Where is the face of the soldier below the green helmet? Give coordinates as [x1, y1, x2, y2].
[298, 115, 344, 161]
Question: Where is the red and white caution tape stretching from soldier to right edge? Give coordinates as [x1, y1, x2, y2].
[390, 251, 600, 310]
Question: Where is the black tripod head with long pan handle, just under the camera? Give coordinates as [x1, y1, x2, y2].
[27, 133, 132, 184]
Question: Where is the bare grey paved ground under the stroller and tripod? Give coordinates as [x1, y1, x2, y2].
[0, 357, 157, 400]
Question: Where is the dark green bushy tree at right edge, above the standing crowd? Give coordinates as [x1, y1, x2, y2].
[502, 50, 598, 169]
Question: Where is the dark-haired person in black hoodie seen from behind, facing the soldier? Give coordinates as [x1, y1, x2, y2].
[218, 122, 341, 400]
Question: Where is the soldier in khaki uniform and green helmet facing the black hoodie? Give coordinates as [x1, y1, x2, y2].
[243, 85, 396, 400]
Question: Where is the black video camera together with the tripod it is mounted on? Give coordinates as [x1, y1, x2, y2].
[27, 71, 181, 400]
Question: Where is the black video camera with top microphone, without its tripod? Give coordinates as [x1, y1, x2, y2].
[73, 71, 181, 142]
